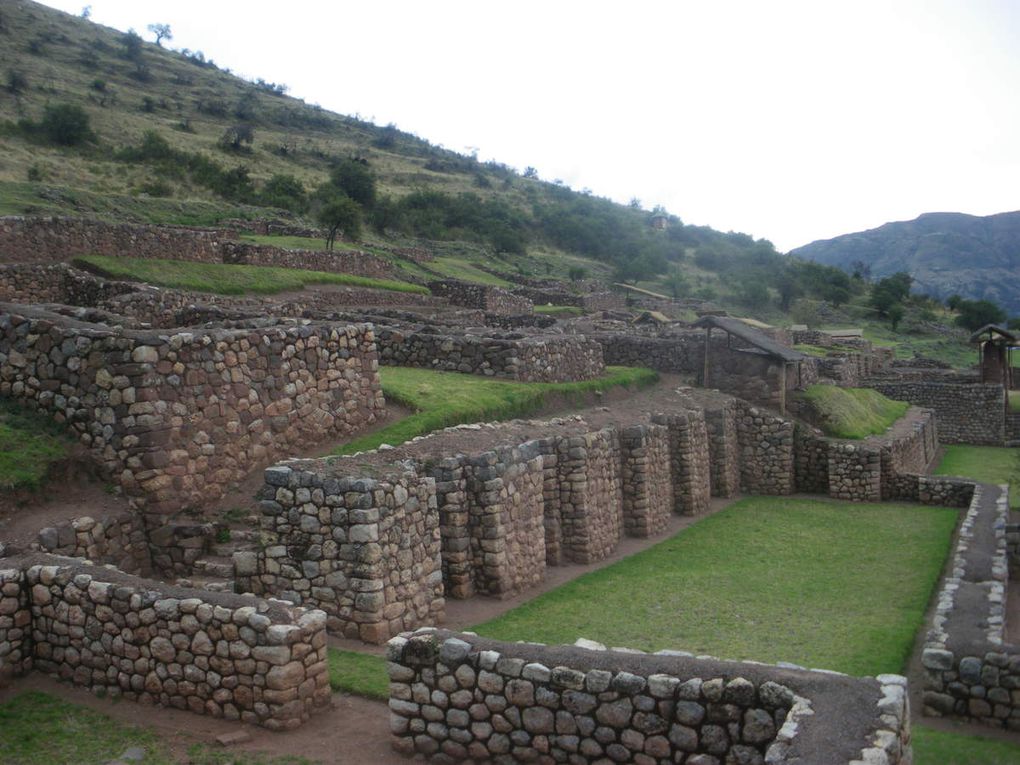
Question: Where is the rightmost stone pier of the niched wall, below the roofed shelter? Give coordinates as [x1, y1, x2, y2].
[736, 408, 794, 495]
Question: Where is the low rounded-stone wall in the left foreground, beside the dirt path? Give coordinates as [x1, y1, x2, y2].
[0, 556, 330, 729]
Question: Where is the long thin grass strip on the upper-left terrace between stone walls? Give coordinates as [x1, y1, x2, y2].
[73, 255, 428, 295]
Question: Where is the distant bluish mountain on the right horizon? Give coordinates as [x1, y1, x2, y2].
[789, 212, 1020, 315]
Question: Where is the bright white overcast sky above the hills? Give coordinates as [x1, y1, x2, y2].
[35, 0, 1020, 251]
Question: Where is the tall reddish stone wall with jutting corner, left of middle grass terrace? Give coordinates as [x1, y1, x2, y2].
[0, 304, 384, 550]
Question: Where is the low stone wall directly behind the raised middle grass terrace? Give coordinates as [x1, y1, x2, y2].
[377, 326, 606, 383]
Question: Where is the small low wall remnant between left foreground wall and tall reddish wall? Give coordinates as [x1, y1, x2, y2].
[39, 510, 152, 575]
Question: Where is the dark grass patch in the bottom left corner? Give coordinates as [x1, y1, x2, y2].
[0, 691, 311, 765]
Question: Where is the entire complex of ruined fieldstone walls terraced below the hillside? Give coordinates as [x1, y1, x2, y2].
[0, 218, 1020, 765]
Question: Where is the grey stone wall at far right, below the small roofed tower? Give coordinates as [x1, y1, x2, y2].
[861, 377, 1006, 446]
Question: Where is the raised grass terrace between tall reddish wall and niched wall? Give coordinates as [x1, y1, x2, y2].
[333, 366, 659, 455]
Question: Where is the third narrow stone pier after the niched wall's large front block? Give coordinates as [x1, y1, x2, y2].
[619, 424, 674, 538]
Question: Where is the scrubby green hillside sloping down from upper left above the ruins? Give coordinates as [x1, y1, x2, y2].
[0, 0, 772, 289]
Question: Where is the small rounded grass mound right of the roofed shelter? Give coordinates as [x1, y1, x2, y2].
[798, 386, 910, 439]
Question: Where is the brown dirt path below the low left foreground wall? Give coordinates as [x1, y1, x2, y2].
[0, 673, 407, 765]
